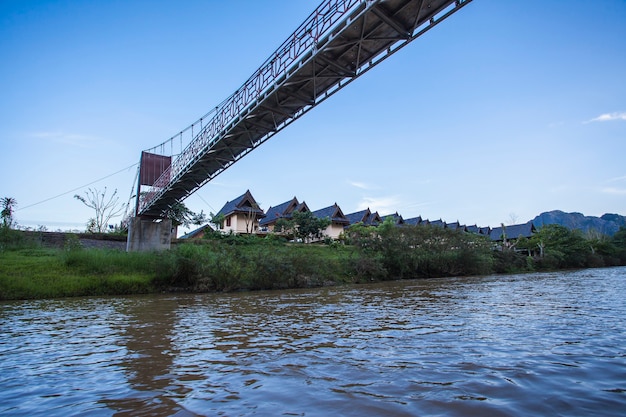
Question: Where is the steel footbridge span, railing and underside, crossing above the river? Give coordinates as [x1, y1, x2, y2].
[135, 0, 472, 217]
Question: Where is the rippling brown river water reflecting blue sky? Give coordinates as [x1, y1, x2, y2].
[0, 268, 626, 417]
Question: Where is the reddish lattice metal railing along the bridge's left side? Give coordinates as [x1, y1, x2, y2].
[137, 0, 360, 213]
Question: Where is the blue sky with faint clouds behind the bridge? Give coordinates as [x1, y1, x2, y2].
[0, 0, 626, 233]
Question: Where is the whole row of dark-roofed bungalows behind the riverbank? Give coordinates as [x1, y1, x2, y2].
[181, 190, 535, 245]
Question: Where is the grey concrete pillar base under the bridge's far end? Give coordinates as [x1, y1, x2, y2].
[126, 217, 172, 252]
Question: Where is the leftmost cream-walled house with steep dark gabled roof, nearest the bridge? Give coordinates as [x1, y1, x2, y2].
[217, 190, 265, 234]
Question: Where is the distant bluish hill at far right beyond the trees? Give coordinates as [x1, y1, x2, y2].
[531, 210, 626, 236]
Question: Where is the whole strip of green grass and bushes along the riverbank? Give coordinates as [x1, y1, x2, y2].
[0, 222, 626, 300]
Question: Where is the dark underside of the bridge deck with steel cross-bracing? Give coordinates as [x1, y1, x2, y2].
[138, 0, 471, 216]
